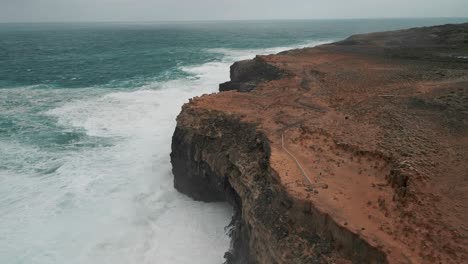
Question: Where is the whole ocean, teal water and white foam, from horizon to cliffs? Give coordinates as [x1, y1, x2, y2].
[0, 19, 467, 264]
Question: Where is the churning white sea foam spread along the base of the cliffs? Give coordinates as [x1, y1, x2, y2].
[0, 39, 330, 264]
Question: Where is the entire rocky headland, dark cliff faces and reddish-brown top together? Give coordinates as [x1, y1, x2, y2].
[171, 24, 468, 264]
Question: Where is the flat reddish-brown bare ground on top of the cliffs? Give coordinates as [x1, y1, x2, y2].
[172, 24, 468, 263]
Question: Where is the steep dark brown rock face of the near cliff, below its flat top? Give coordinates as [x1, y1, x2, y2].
[171, 105, 386, 264]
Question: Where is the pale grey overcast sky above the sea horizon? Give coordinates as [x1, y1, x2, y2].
[0, 0, 468, 22]
